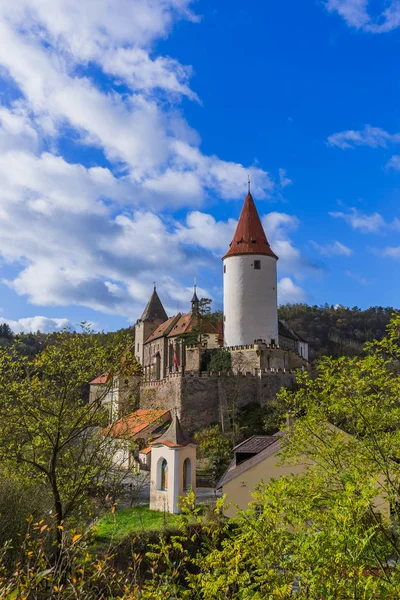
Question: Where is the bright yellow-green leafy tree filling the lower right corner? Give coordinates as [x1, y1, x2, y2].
[188, 317, 400, 600]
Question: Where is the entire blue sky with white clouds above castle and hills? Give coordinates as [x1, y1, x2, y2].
[0, 0, 400, 331]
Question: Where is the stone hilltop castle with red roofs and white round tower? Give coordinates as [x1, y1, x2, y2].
[130, 186, 308, 431]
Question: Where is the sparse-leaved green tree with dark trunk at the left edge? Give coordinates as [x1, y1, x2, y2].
[0, 328, 139, 546]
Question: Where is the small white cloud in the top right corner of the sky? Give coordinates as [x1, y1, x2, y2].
[325, 0, 400, 33]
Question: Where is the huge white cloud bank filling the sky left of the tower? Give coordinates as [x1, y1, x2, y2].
[0, 0, 289, 319]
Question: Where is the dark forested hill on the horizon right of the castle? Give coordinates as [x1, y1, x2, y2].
[279, 304, 396, 360]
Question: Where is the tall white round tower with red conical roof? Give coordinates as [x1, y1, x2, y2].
[222, 184, 278, 347]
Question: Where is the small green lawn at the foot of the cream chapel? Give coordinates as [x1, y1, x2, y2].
[96, 506, 186, 543]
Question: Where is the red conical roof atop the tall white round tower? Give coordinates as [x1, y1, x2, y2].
[223, 192, 278, 259]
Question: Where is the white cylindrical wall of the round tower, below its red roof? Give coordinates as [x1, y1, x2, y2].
[224, 254, 278, 346]
